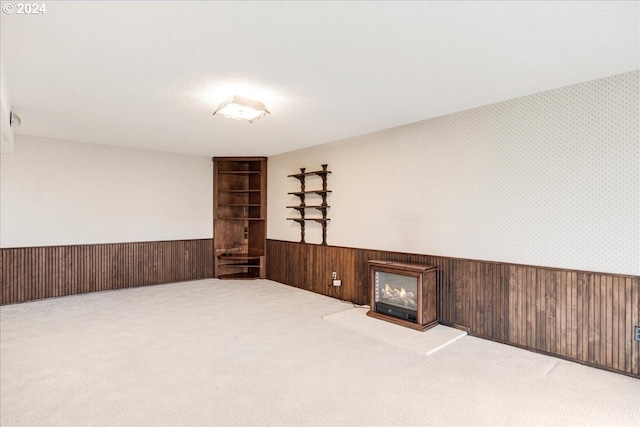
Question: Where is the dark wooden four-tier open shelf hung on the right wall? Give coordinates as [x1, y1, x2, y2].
[287, 165, 331, 246]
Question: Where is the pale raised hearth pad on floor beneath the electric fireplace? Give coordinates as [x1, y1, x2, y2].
[324, 308, 467, 356]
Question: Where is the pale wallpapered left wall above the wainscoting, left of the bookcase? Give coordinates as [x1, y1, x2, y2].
[0, 135, 213, 248]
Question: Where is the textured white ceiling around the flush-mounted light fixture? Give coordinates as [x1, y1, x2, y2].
[1, 1, 640, 156]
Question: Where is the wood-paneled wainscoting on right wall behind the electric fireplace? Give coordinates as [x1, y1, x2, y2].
[267, 240, 640, 378]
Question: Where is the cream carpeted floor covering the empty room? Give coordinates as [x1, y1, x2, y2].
[0, 279, 640, 427]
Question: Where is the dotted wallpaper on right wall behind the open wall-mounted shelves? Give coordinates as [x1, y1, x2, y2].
[268, 71, 640, 275]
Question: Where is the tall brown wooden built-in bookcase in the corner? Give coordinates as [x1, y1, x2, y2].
[213, 157, 267, 279]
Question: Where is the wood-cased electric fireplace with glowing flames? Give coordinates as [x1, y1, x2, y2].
[367, 261, 438, 331]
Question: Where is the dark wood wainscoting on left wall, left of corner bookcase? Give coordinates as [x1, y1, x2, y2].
[0, 239, 213, 304]
